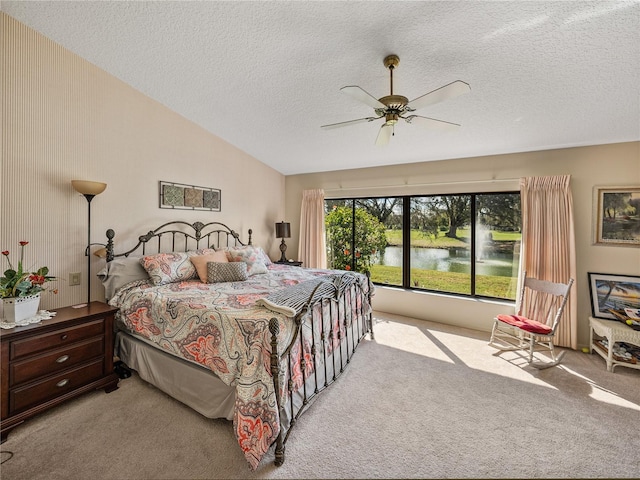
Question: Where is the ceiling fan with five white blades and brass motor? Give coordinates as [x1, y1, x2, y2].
[321, 55, 471, 146]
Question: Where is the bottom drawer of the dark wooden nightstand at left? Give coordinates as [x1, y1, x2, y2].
[9, 358, 104, 415]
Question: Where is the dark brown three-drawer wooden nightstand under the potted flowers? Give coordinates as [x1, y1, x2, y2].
[0, 302, 119, 442]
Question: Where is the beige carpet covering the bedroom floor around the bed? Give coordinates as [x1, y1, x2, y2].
[0, 315, 640, 480]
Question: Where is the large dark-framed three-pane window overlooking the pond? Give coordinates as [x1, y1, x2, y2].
[325, 192, 521, 300]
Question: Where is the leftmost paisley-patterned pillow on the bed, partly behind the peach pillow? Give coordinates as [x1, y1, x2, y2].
[140, 248, 216, 285]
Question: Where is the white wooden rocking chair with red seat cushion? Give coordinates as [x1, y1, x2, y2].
[489, 272, 574, 368]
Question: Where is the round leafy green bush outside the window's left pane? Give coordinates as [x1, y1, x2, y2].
[325, 205, 387, 272]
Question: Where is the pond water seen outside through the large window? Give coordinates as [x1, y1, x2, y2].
[380, 247, 519, 277]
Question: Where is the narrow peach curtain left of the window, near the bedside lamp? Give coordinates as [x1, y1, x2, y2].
[298, 189, 327, 268]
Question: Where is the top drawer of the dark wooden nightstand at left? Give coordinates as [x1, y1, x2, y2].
[9, 318, 104, 360]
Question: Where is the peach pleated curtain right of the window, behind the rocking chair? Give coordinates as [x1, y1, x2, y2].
[516, 175, 578, 349]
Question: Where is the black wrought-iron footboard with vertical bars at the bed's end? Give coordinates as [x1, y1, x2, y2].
[269, 274, 373, 466]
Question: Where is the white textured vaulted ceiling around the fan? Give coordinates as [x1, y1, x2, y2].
[0, 0, 640, 175]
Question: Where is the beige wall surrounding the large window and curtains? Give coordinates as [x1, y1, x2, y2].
[285, 142, 640, 346]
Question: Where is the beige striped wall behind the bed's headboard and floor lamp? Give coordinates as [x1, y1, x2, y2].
[0, 12, 284, 308]
